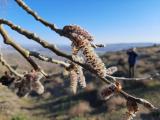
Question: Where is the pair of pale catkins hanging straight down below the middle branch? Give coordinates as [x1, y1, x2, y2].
[67, 63, 86, 94]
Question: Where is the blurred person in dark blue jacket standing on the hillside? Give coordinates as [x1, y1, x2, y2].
[127, 48, 138, 78]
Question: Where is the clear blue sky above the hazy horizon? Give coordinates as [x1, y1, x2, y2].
[0, 0, 160, 44]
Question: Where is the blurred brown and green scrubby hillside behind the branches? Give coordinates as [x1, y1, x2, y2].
[0, 46, 160, 120]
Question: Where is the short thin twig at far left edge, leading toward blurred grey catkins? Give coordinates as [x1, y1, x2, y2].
[0, 53, 23, 78]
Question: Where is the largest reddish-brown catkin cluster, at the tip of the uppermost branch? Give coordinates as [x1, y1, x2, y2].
[63, 25, 106, 77]
